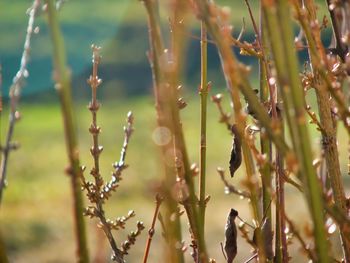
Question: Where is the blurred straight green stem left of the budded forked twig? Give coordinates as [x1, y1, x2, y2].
[46, 0, 89, 262]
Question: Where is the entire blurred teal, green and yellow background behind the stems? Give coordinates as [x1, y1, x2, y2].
[0, 0, 349, 263]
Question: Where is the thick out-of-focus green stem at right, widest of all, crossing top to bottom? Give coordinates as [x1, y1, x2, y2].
[263, 0, 330, 262]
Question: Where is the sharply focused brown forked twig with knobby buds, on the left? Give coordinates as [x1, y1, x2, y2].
[81, 45, 139, 263]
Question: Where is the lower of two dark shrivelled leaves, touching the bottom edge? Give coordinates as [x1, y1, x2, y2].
[224, 208, 238, 263]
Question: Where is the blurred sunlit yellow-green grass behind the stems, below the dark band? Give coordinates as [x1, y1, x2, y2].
[0, 95, 349, 262]
